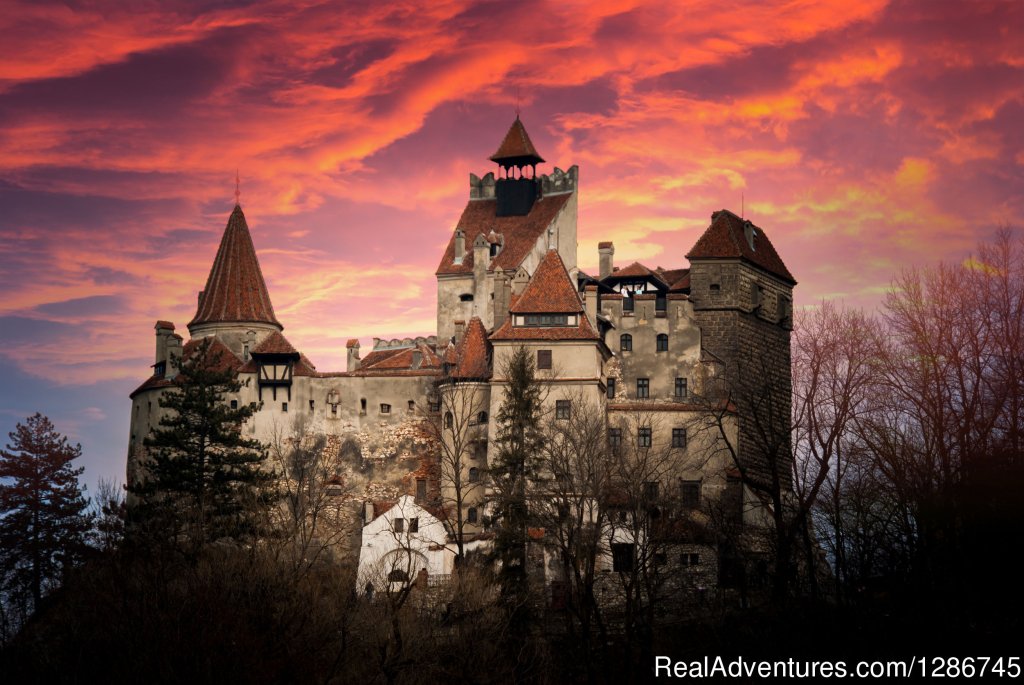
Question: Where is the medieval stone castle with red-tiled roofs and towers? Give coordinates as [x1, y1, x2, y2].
[127, 117, 796, 583]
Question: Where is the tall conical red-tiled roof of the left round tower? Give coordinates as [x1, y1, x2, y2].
[188, 205, 282, 328]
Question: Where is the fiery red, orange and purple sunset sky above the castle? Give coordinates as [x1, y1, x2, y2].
[0, 0, 1024, 489]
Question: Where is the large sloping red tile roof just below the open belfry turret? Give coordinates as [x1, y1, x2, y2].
[437, 192, 571, 275]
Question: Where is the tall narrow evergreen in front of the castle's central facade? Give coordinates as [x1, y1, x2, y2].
[490, 347, 544, 676]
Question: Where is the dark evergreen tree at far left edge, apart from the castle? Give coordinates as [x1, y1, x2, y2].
[0, 413, 90, 606]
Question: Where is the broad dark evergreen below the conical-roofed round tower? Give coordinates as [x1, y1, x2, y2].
[129, 338, 276, 547]
